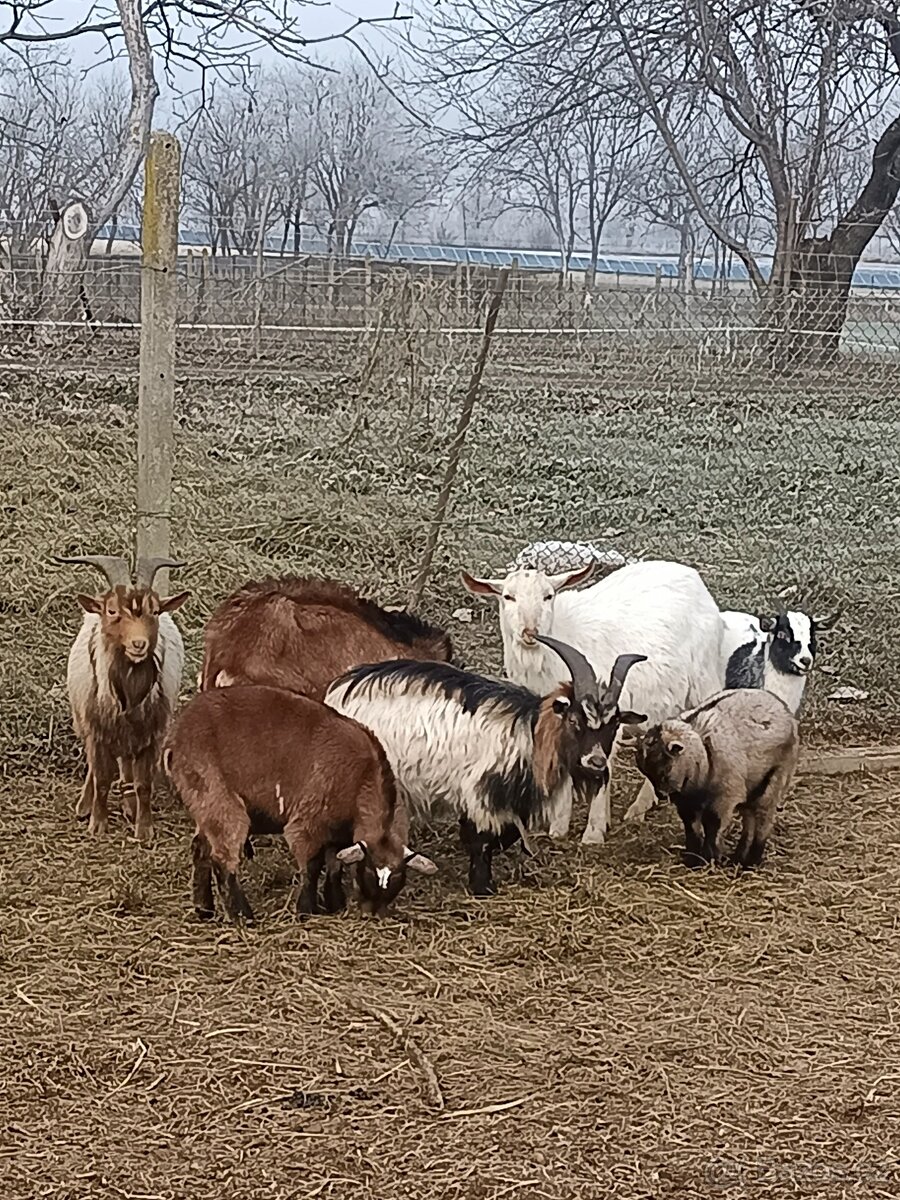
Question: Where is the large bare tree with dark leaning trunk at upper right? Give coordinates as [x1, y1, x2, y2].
[412, 0, 900, 362]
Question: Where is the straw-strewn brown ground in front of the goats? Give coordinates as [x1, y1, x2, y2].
[0, 775, 900, 1200]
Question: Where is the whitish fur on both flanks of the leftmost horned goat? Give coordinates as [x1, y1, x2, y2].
[66, 612, 185, 740]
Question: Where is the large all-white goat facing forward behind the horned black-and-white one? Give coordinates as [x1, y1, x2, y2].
[462, 560, 722, 844]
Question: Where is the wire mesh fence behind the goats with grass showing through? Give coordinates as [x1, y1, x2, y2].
[0, 256, 900, 769]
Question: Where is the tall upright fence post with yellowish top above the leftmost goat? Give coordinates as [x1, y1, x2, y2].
[136, 133, 181, 594]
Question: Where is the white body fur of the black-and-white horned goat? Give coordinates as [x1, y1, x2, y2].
[325, 680, 572, 836]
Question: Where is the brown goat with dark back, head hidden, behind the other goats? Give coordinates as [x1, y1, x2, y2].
[200, 576, 451, 700]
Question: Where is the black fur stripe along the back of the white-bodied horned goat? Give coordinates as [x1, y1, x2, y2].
[331, 659, 541, 726]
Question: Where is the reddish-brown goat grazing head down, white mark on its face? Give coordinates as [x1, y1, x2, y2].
[164, 685, 437, 922]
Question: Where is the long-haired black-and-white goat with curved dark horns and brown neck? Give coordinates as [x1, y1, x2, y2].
[325, 637, 644, 896]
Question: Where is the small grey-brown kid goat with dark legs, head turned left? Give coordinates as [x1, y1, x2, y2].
[636, 690, 799, 868]
